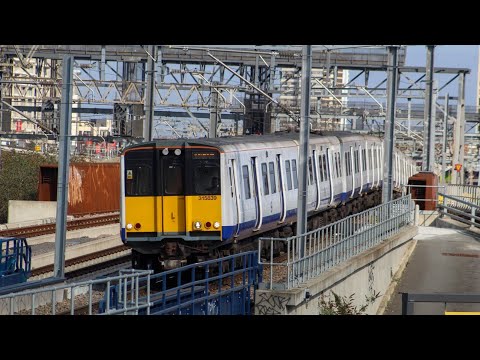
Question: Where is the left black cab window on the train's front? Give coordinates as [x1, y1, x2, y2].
[124, 150, 155, 196]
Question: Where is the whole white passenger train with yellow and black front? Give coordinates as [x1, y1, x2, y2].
[120, 132, 415, 272]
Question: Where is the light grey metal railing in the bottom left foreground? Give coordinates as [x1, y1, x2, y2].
[0, 269, 152, 315]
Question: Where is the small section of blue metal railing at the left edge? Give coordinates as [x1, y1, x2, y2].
[0, 237, 32, 287]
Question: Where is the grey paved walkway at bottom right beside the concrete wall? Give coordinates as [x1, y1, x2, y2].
[384, 227, 480, 315]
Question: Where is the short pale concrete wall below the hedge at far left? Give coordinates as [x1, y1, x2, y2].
[8, 200, 57, 223]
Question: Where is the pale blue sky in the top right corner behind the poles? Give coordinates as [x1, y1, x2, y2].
[405, 45, 479, 106]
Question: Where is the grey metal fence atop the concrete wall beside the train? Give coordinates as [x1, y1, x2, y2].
[258, 195, 414, 289]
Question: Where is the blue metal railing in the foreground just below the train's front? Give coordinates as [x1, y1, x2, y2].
[100, 251, 262, 315]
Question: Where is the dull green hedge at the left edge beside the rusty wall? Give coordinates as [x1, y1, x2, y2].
[0, 150, 57, 224]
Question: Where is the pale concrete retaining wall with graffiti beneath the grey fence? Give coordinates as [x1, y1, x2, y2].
[255, 226, 417, 315]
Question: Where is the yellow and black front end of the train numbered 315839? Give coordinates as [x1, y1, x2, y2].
[120, 140, 222, 268]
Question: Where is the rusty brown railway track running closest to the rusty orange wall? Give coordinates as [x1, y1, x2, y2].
[0, 214, 120, 238]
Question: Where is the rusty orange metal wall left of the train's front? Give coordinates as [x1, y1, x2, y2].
[38, 163, 120, 215]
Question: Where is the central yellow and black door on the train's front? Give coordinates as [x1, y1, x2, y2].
[158, 149, 186, 235]
